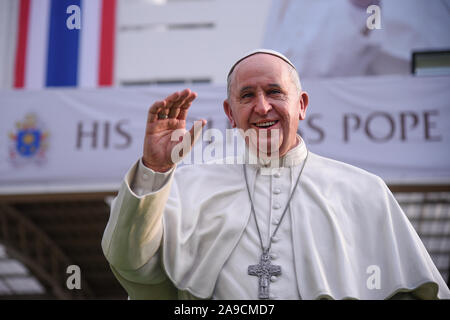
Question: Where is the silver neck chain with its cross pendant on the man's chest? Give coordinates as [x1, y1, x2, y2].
[243, 151, 309, 299]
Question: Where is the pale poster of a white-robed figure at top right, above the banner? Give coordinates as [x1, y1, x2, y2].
[263, 0, 450, 78]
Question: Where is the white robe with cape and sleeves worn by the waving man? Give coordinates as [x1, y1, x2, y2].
[102, 140, 450, 299]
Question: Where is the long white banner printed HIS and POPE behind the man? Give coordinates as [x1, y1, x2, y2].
[0, 77, 450, 194]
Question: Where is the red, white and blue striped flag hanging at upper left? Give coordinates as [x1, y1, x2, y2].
[14, 0, 116, 89]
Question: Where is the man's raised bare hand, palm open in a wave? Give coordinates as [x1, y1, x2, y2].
[142, 89, 206, 172]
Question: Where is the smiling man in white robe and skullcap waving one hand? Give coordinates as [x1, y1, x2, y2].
[102, 49, 450, 299]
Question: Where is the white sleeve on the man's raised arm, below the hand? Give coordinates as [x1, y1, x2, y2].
[102, 160, 175, 284]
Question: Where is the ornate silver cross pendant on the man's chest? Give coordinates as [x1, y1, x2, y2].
[248, 251, 281, 299]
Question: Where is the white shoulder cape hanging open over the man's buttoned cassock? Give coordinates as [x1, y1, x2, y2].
[162, 152, 450, 299]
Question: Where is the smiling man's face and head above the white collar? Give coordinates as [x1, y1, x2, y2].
[224, 53, 308, 157]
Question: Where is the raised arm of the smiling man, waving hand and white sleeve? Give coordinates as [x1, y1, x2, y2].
[102, 89, 206, 298]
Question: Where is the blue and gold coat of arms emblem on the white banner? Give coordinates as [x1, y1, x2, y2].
[9, 113, 49, 165]
